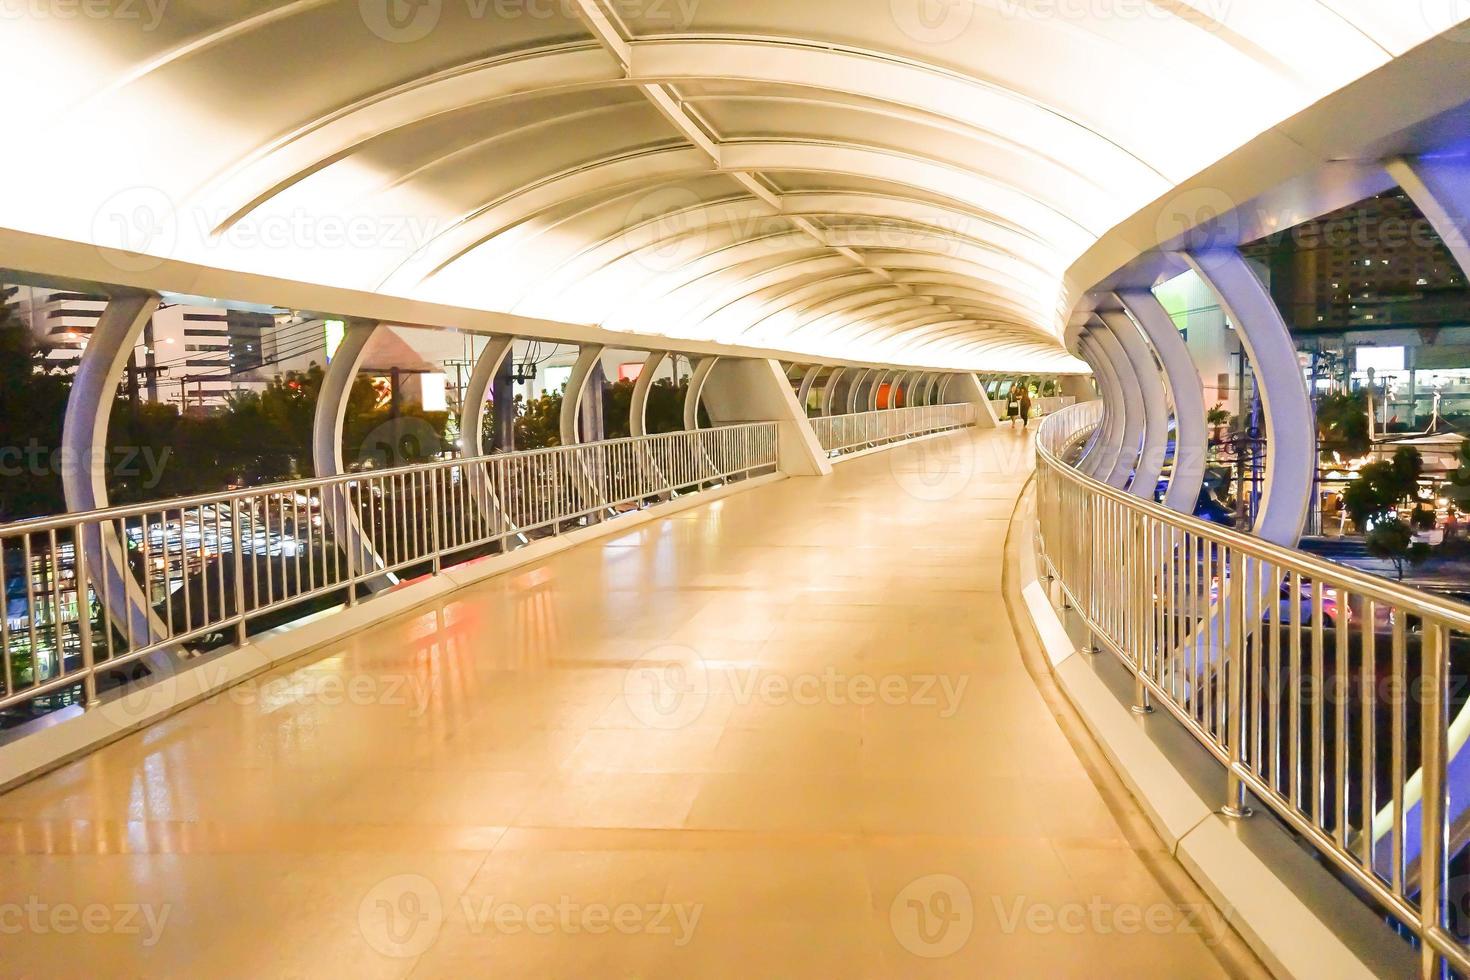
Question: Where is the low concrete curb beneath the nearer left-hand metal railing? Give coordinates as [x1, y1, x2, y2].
[0, 473, 786, 792]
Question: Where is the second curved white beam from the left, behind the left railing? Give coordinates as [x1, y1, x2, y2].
[312, 320, 397, 591]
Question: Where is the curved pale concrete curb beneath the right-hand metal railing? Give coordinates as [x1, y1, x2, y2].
[1004, 478, 1419, 979]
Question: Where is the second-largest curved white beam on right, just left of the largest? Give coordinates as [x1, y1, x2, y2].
[1117, 289, 1210, 514]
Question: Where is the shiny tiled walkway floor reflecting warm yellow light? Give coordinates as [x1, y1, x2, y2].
[0, 429, 1240, 979]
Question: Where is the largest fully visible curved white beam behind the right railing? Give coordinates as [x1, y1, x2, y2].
[1185, 248, 1317, 548]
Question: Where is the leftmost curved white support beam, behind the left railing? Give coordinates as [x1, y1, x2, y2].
[62, 292, 168, 667]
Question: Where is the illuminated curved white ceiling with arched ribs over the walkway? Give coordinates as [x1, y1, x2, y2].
[0, 0, 1452, 370]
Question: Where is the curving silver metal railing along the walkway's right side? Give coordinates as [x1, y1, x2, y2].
[1036, 403, 1470, 976]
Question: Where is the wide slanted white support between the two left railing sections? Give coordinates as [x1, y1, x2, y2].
[685, 357, 832, 476]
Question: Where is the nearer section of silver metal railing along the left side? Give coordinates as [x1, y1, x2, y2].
[0, 422, 778, 725]
